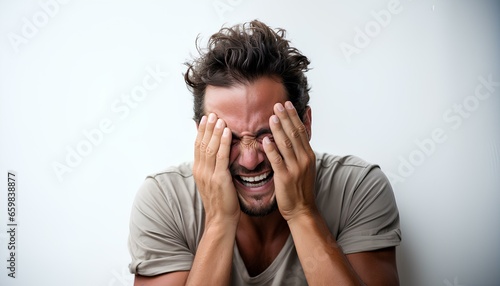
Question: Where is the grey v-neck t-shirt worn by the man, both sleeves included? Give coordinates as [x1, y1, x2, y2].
[128, 153, 401, 285]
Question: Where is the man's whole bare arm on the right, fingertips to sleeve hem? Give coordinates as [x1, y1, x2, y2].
[264, 102, 398, 285]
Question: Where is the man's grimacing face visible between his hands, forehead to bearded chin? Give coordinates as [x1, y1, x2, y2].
[204, 77, 287, 216]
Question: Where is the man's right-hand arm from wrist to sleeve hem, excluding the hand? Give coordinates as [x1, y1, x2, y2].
[289, 209, 399, 286]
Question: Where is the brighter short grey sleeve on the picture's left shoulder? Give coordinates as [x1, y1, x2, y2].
[128, 177, 194, 276]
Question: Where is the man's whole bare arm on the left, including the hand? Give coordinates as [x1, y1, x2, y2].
[134, 114, 240, 286]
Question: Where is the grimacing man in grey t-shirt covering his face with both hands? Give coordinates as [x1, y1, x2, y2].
[129, 21, 400, 286]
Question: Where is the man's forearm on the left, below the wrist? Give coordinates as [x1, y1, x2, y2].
[186, 223, 236, 285]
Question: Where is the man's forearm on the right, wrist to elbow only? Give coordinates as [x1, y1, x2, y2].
[288, 210, 363, 285]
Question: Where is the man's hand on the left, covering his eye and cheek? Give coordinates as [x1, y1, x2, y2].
[193, 113, 240, 224]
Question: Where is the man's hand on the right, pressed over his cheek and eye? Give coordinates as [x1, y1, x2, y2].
[264, 101, 316, 221]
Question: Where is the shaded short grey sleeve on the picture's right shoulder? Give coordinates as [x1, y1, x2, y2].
[337, 165, 401, 254]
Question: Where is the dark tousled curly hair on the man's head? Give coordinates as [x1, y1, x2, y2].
[184, 20, 310, 122]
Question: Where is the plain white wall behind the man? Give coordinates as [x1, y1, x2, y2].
[0, 0, 500, 285]
